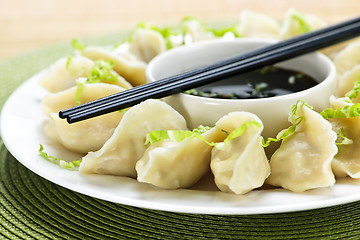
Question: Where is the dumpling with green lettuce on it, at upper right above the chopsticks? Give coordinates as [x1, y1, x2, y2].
[279, 9, 327, 40]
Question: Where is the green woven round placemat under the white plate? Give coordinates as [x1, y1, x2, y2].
[0, 33, 360, 239]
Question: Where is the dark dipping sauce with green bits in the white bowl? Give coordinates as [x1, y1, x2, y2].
[185, 66, 318, 99]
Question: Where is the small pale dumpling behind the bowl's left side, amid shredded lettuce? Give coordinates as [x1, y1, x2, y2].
[130, 28, 166, 63]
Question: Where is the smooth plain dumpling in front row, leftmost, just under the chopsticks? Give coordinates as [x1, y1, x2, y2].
[79, 99, 187, 178]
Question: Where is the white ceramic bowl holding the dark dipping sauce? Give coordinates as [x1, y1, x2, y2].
[146, 38, 336, 138]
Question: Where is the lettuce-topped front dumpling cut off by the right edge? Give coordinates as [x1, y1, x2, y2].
[321, 96, 360, 178]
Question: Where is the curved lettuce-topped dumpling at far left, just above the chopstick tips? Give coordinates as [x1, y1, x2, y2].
[39, 56, 132, 93]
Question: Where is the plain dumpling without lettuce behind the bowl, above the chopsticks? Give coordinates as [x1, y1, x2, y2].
[238, 10, 280, 39]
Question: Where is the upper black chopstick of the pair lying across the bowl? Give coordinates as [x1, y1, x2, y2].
[59, 17, 360, 118]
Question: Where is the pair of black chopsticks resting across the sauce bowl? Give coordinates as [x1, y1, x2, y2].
[59, 17, 360, 123]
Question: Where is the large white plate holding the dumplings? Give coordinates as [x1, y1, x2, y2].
[1, 73, 360, 215]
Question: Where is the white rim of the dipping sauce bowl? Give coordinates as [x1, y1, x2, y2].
[146, 38, 336, 104]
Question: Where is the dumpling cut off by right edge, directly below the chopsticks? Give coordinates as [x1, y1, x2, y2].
[334, 41, 360, 74]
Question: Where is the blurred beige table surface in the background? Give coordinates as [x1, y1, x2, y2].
[0, 0, 360, 60]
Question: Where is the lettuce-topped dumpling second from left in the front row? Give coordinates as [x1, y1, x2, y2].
[136, 126, 226, 189]
